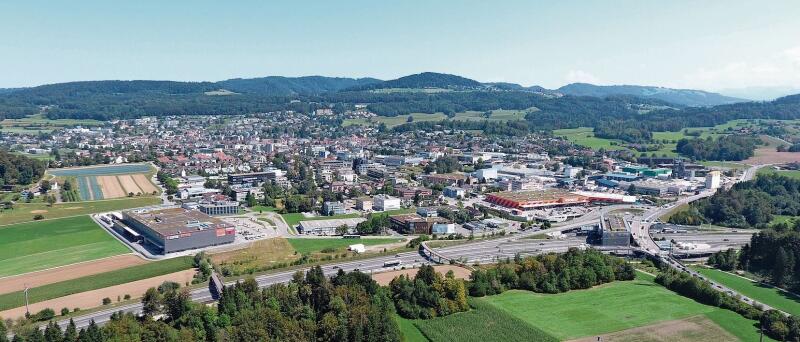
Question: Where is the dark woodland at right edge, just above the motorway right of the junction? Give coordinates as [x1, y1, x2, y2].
[669, 174, 800, 228]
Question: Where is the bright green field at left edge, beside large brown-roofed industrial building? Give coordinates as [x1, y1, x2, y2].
[0, 216, 130, 277]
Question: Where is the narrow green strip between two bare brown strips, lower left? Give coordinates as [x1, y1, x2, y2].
[0, 256, 193, 310]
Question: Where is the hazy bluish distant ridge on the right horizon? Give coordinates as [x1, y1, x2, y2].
[557, 83, 748, 107]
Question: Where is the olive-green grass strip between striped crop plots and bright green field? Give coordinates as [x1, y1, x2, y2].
[0, 197, 161, 229]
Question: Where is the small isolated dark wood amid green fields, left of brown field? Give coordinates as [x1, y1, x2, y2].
[675, 135, 758, 160]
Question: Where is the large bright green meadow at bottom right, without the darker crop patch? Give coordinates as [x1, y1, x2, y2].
[487, 274, 768, 340]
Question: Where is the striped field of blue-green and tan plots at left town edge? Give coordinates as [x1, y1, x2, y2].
[47, 164, 159, 201]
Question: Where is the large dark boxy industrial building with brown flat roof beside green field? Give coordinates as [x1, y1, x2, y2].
[122, 208, 236, 254]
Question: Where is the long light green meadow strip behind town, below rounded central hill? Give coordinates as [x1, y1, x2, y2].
[342, 108, 537, 128]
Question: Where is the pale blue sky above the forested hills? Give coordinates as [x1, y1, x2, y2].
[0, 0, 800, 90]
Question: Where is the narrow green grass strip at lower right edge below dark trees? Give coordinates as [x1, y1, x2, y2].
[695, 267, 800, 315]
